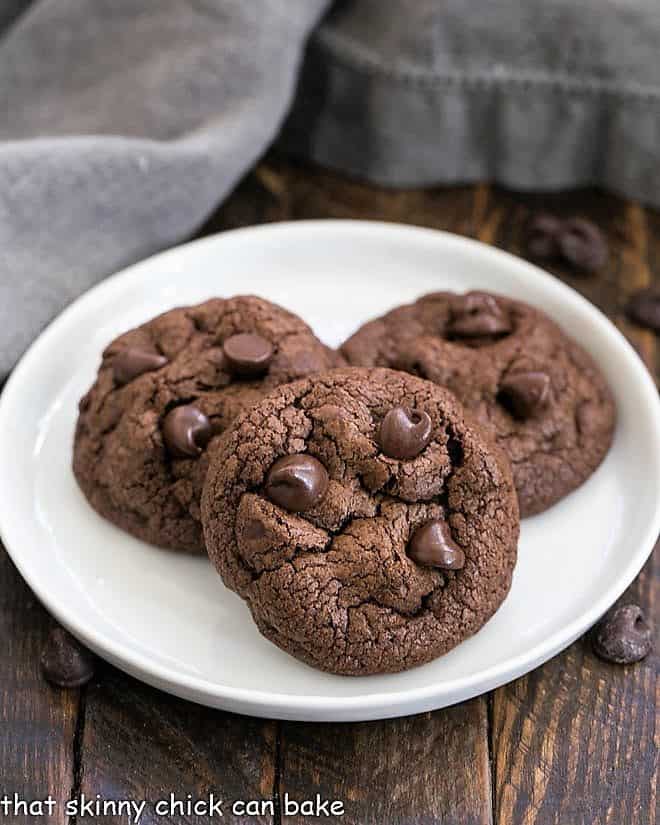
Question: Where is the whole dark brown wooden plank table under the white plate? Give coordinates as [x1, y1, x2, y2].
[0, 158, 660, 825]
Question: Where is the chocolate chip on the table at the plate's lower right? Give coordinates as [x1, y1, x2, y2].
[593, 604, 653, 665]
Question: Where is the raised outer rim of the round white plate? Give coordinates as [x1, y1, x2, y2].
[0, 219, 660, 721]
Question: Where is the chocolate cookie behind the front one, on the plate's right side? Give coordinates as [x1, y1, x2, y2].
[342, 292, 616, 516]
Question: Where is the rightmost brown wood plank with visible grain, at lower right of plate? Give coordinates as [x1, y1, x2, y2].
[492, 549, 660, 825]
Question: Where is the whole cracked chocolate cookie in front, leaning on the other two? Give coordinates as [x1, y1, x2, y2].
[202, 369, 519, 675]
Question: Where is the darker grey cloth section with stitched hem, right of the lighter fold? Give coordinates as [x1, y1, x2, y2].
[280, 0, 660, 198]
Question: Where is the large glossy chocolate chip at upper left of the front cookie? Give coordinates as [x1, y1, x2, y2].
[266, 453, 328, 513]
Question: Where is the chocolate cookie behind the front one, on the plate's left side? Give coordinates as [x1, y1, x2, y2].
[73, 297, 342, 553]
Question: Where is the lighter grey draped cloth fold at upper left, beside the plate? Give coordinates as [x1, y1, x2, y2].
[0, 0, 328, 380]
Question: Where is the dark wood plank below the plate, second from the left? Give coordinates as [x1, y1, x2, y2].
[79, 665, 276, 825]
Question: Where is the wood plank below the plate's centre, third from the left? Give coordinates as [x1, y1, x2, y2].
[280, 699, 492, 825]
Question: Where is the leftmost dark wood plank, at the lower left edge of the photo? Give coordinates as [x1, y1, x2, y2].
[0, 545, 80, 825]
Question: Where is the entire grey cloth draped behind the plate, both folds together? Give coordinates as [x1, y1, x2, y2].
[0, 0, 660, 380]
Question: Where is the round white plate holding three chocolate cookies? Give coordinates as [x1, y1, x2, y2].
[0, 221, 660, 720]
